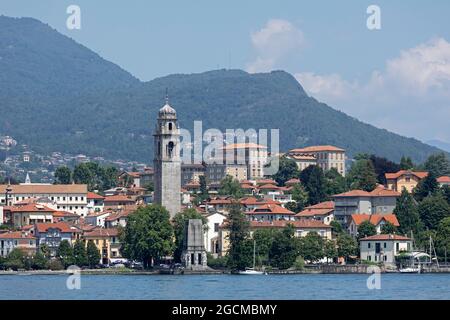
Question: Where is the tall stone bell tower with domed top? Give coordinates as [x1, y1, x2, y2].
[153, 99, 181, 218]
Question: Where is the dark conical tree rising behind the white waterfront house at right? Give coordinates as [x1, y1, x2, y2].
[394, 190, 422, 236]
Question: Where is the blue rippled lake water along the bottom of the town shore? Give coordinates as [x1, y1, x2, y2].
[0, 274, 450, 300]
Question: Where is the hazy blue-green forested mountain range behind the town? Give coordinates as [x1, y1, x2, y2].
[0, 16, 439, 163]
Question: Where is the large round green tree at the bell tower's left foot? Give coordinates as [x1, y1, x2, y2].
[120, 204, 174, 268]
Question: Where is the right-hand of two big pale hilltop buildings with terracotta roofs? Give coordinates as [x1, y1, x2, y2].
[288, 146, 345, 176]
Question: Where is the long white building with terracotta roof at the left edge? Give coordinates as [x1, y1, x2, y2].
[0, 183, 88, 217]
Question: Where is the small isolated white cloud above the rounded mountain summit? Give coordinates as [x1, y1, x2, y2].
[247, 19, 305, 73]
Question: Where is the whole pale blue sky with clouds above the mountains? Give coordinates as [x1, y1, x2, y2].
[0, 0, 450, 142]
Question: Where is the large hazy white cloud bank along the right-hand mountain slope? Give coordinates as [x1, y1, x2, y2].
[295, 38, 450, 141]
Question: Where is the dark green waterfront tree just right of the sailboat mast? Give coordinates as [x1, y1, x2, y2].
[269, 225, 299, 269]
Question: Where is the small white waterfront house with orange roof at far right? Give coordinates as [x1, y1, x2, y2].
[359, 234, 412, 265]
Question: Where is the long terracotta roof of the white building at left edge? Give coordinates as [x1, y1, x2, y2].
[0, 184, 87, 194]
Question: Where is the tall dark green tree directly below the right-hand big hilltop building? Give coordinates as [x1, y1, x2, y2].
[300, 166, 327, 205]
